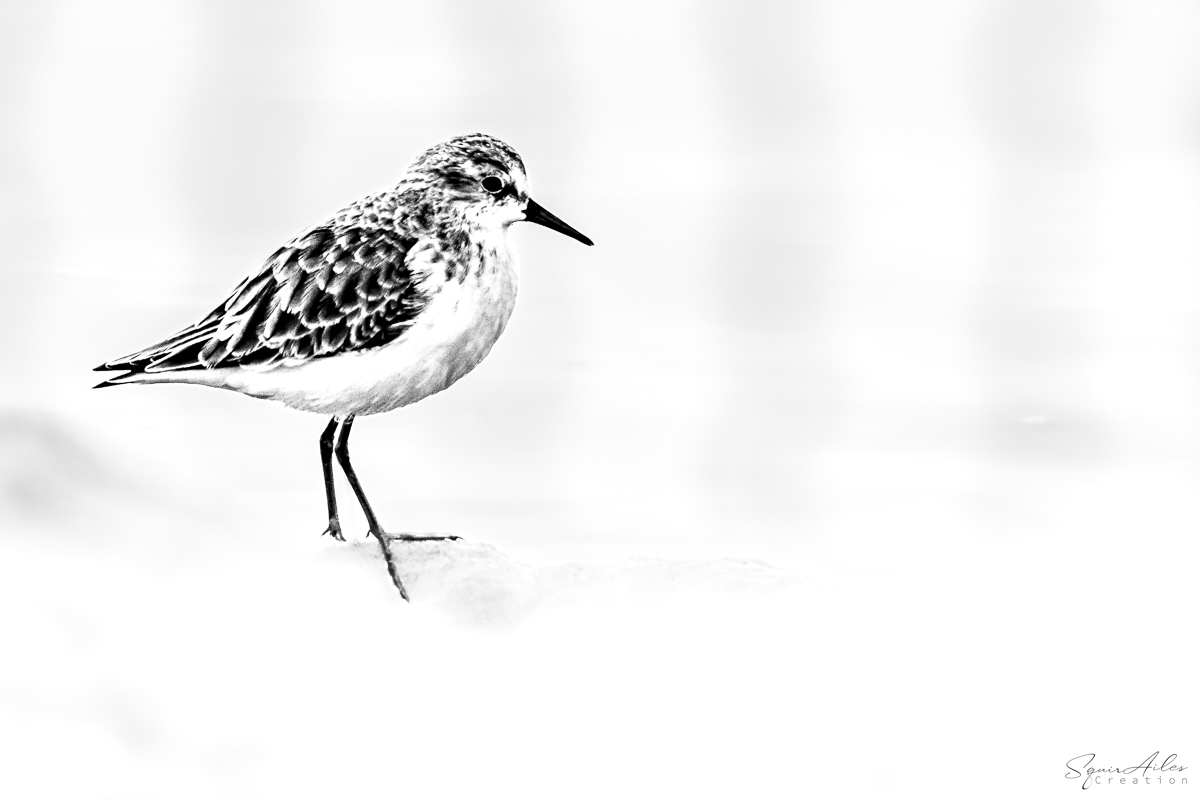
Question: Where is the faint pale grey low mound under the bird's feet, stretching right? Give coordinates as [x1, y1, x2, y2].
[328, 540, 797, 626]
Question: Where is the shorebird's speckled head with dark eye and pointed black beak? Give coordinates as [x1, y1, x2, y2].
[406, 133, 592, 245]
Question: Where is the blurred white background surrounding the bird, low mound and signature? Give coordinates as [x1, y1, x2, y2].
[0, 0, 1200, 798]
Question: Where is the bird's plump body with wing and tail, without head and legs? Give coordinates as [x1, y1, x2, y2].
[97, 191, 516, 414]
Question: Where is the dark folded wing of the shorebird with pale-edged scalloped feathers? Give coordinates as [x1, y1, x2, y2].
[96, 227, 426, 378]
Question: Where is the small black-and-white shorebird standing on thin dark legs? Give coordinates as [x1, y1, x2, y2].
[95, 133, 593, 601]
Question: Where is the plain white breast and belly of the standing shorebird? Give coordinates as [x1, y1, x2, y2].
[224, 243, 517, 415]
